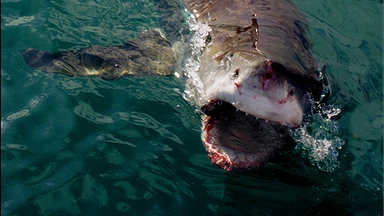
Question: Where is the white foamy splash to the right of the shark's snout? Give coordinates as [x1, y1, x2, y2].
[292, 106, 344, 172]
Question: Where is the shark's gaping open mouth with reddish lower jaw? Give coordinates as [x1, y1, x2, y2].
[202, 101, 293, 171]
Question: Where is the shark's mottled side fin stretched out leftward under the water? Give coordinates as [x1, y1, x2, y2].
[21, 29, 178, 79]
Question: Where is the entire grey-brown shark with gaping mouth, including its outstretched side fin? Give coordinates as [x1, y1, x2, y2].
[22, 0, 327, 171]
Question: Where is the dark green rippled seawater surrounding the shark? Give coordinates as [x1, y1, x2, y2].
[1, 0, 384, 215]
